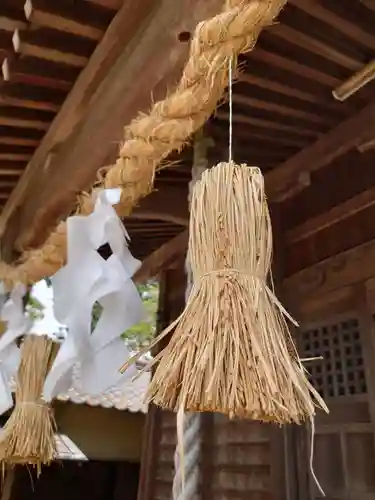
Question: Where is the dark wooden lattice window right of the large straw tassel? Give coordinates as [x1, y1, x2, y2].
[299, 318, 367, 398]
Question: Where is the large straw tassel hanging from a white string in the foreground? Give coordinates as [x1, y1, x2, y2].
[137, 163, 328, 424]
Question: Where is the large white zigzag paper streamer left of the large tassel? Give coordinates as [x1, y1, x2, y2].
[44, 189, 144, 401]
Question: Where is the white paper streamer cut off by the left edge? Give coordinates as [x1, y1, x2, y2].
[0, 285, 31, 415]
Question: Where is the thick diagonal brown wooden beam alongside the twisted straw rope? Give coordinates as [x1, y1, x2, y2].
[0, 0, 226, 250]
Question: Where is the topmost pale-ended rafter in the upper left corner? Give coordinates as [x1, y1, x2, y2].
[24, 0, 113, 41]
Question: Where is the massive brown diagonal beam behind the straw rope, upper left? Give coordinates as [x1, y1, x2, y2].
[0, 0, 222, 250]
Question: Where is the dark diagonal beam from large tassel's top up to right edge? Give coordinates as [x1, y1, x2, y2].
[265, 101, 375, 201]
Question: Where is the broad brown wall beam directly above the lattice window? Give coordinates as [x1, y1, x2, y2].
[283, 240, 375, 303]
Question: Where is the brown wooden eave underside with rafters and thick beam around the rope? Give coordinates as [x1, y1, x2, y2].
[0, 0, 375, 292]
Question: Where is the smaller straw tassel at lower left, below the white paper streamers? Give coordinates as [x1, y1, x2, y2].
[0, 334, 57, 475]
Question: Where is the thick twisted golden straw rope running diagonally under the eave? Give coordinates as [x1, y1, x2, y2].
[0, 0, 287, 288]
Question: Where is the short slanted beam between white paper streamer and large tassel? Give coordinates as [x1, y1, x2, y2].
[134, 230, 189, 283]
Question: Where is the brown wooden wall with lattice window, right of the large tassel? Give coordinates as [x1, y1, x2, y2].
[281, 149, 375, 500]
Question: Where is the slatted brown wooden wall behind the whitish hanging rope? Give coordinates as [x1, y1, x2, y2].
[138, 261, 282, 500]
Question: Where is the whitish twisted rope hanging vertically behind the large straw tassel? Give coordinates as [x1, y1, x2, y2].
[172, 133, 209, 500]
